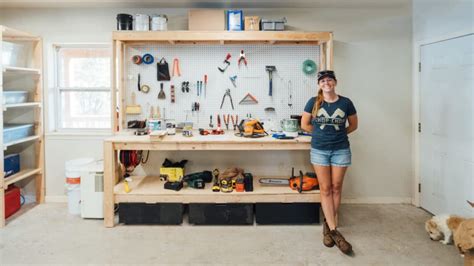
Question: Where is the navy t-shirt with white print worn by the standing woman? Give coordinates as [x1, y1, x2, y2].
[304, 95, 356, 150]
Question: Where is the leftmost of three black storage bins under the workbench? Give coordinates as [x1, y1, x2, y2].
[119, 203, 184, 224]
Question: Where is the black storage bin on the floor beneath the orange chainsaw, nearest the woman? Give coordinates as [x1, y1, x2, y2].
[255, 203, 321, 224]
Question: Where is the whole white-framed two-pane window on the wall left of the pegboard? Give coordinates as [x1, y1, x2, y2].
[55, 45, 111, 130]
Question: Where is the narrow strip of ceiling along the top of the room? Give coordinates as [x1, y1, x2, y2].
[0, 0, 411, 8]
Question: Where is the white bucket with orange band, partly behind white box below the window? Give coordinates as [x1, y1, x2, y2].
[65, 158, 94, 215]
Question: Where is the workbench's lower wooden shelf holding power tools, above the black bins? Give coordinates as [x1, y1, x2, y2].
[114, 176, 321, 204]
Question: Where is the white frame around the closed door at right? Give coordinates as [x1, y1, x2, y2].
[411, 30, 474, 207]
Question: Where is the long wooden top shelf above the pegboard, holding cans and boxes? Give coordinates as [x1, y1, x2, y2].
[112, 31, 332, 45]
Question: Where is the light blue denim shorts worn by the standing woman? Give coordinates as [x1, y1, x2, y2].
[311, 148, 352, 167]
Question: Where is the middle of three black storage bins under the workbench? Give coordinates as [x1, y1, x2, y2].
[189, 203, 253, 225]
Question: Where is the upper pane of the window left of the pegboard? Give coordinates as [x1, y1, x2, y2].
[58, 48, 110, 88]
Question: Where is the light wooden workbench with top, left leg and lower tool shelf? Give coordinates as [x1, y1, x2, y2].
[104, 131, 321, 227]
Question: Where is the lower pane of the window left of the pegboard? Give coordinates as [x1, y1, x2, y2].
[61, 91, 111, 129]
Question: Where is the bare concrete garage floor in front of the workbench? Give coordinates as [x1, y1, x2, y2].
[0, 203, 463, 265]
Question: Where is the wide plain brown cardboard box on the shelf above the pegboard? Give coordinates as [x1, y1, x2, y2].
[188, 9, 226, 31]
